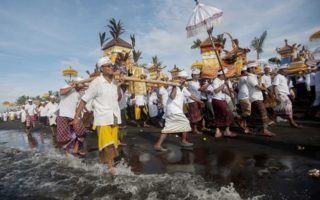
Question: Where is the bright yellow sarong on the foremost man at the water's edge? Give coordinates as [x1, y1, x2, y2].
[97, 125, 119, 151]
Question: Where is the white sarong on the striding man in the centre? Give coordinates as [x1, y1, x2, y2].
[161, 113, 191, 133]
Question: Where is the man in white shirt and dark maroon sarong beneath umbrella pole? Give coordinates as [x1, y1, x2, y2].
[212, 69, 236, 138]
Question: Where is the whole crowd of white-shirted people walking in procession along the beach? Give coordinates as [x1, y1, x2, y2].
[1, 57, 320, 174]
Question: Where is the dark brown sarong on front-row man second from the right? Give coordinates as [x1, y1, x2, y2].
[249, 100, 269, 128]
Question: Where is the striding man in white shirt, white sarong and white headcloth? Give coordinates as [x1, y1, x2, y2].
[154, 71, 203, 151]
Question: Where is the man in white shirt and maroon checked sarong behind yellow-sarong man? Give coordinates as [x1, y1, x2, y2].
[56, 77, 86, 155]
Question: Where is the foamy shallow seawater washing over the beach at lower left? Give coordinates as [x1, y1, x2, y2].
[0, 131, 263, 200]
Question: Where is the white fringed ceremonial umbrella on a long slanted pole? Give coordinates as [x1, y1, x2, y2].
[186, 0, 234, 103]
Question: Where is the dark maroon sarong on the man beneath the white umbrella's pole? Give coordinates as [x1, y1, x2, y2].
[212, 99, 233, 128]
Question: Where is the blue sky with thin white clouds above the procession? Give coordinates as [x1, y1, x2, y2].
[0, 0, 320, 110]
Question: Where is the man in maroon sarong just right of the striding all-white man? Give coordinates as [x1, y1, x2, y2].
[188, 69, 203, 134]
